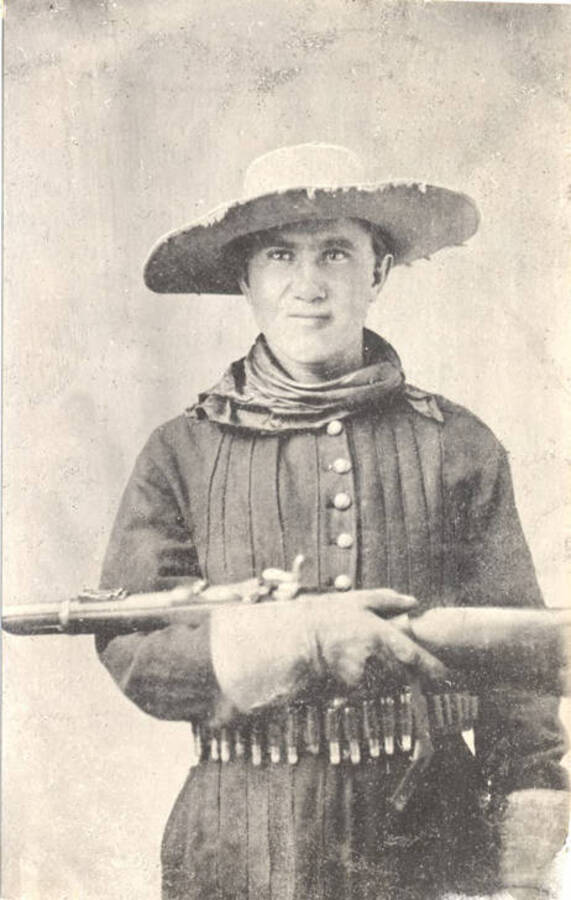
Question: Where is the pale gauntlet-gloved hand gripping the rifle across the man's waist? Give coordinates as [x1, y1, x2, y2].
[210, 588, 447, 712]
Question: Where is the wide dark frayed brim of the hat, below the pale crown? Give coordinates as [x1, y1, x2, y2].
[144, 182, 479, 294]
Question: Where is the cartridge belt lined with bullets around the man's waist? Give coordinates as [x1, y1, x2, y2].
[192, 690, 478, 766]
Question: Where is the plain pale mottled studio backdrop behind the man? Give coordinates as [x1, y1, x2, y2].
[2, 0, 571, 900]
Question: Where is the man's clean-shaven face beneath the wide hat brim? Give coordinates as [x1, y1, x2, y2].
[241, 219, 386, 371]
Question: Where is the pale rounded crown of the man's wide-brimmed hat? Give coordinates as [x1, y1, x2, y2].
[243, 143, 365, 200]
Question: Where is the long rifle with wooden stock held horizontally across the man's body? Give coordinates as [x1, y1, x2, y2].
[2, 567, 571, 695]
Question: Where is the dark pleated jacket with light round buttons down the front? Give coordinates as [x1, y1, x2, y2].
[99, 390, 565, 900]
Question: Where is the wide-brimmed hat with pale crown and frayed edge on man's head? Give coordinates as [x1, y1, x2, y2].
[144, 143, 479, 294]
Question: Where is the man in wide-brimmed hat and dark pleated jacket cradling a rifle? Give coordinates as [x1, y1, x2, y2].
[98, 145, 566, 900]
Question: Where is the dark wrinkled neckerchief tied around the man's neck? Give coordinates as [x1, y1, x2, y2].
[187, 329, 443, 432]
